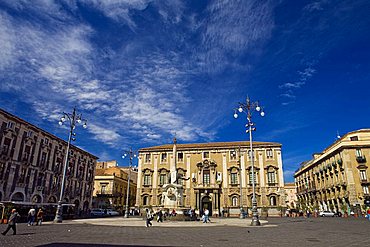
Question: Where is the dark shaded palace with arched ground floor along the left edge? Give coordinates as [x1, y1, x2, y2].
[0, 109, 97, 213]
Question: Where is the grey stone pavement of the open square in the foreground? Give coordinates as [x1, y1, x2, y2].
[0, 217, 370, 247]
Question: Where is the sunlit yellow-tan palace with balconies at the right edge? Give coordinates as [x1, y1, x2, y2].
[294, 129, 370, 214]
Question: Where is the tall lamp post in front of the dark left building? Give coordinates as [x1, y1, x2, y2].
[54, 107, 87, 223]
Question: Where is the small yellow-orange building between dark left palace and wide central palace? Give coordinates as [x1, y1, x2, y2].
[93, 162, 137, 211]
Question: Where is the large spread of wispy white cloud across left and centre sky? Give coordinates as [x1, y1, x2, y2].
[0, 0, 273, 155]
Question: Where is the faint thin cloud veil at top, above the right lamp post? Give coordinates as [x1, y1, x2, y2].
[198, 0, 274, 73]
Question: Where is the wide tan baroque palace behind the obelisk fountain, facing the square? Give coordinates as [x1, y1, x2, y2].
[136, 142, 285, 215]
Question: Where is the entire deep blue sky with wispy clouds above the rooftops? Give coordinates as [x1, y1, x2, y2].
[0, 0, 370, 181]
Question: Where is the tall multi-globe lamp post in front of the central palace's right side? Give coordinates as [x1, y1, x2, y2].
[234, 97, 265, 226]
